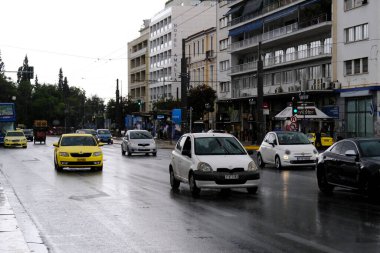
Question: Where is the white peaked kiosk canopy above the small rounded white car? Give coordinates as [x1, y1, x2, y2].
[274, 105, 332, 120]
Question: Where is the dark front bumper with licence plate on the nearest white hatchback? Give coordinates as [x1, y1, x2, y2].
[194, 171, 260, 189]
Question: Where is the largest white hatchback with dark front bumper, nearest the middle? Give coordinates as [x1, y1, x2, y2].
[169, 133, 260, 196]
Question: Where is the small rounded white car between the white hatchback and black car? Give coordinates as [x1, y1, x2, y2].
[257, 131, 318, 169]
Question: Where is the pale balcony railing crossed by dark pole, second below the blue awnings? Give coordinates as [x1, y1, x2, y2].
[231, 44, 332, 74]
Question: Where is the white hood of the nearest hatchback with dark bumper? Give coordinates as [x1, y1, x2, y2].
[197, 155, 253, 170]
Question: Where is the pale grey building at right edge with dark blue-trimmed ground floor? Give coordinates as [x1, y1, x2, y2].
[333, 0, 380, 137]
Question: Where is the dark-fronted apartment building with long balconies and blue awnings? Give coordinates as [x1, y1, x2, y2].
[224, 0, 336, 139]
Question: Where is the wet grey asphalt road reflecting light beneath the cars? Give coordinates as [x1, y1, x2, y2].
[0, 137, 380, 253]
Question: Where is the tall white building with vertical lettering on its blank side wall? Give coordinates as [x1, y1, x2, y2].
[149, 1, 216, 110]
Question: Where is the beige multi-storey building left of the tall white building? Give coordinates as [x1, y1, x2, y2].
[128, 20, 150, 112]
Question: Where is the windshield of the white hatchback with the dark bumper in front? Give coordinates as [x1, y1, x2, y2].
[194, 137, 247, 155]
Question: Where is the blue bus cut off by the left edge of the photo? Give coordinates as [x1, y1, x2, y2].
[0, 103, 16, 145]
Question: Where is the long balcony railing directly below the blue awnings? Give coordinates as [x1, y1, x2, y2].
[231, 14, 328, 52]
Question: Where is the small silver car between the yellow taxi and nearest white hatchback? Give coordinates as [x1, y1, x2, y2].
[121, 130, 157, 156]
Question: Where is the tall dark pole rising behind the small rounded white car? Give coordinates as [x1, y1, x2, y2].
[256, 41, 265, 144]
